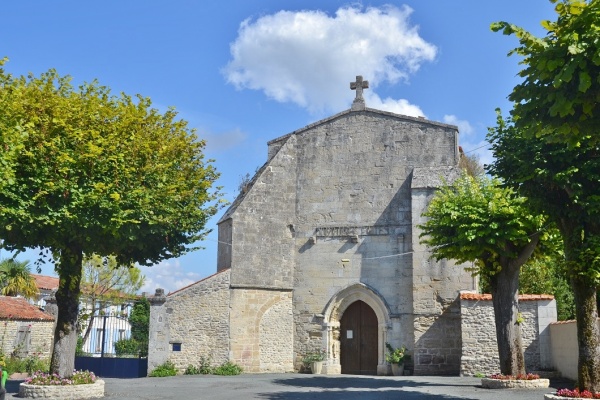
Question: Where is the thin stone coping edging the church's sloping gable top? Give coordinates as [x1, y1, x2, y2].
[217, 108, 458, 225]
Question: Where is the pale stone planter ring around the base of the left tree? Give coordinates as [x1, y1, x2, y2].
[19, 379, 104, 400]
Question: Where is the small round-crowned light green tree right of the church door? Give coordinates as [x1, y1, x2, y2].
[420, 174, 543, 375]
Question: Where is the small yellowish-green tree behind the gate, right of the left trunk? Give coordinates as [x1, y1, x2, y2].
[79, 255, 146, 343]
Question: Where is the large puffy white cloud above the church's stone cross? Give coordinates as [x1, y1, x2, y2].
[223, 6, 437, 115]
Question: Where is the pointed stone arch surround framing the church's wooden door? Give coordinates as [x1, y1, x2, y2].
[323, 283, 391, 375]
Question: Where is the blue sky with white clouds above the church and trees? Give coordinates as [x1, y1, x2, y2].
[0, 0, 555, 292]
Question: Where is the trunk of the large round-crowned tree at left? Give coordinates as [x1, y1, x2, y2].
[50, 246, 83, 378]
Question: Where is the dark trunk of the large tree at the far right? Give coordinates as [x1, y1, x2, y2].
[571, 276, 600, 392]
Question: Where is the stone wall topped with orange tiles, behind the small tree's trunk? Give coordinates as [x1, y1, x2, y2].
[460, 293, 556, 376]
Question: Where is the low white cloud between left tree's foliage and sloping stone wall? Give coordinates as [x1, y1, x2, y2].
[139, 259, 202, 295]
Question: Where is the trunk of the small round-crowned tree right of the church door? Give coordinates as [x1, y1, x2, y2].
[490, 265, 525, 376]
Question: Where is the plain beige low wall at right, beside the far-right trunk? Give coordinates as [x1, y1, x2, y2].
[550, 318, 600, 380]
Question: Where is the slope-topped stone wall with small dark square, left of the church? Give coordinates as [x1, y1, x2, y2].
[148, 270, 230, 372]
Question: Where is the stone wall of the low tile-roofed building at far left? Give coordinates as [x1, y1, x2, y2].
[0, 320, 54, 359]
